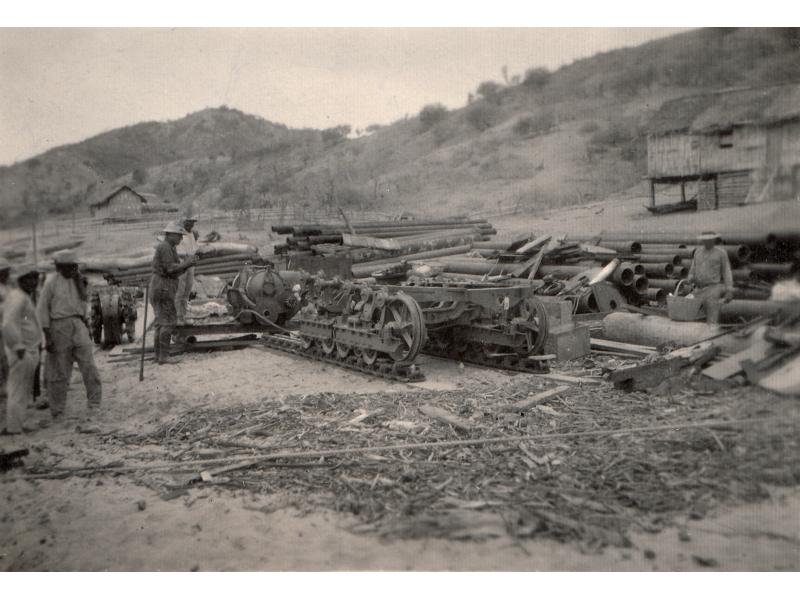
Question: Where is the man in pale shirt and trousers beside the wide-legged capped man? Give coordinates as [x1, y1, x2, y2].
[2, 266, 42, 435]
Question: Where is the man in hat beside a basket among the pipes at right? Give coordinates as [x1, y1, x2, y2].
[687, 231, 733, 325]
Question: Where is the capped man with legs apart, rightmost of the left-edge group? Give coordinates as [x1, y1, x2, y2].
[37, 250, 103, 418]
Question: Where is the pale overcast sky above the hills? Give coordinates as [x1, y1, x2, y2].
[0, 28, 681, 164]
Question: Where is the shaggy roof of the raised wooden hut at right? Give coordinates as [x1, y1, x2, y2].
[647, 83, 800, 134]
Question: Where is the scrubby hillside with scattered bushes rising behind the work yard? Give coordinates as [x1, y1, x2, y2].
[0, 28, 800, 223]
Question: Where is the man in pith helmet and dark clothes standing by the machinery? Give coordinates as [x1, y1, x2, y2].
[150, 223, 198, 365]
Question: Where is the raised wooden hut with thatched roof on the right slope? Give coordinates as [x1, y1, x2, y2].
[647, 83, 800, 210]
